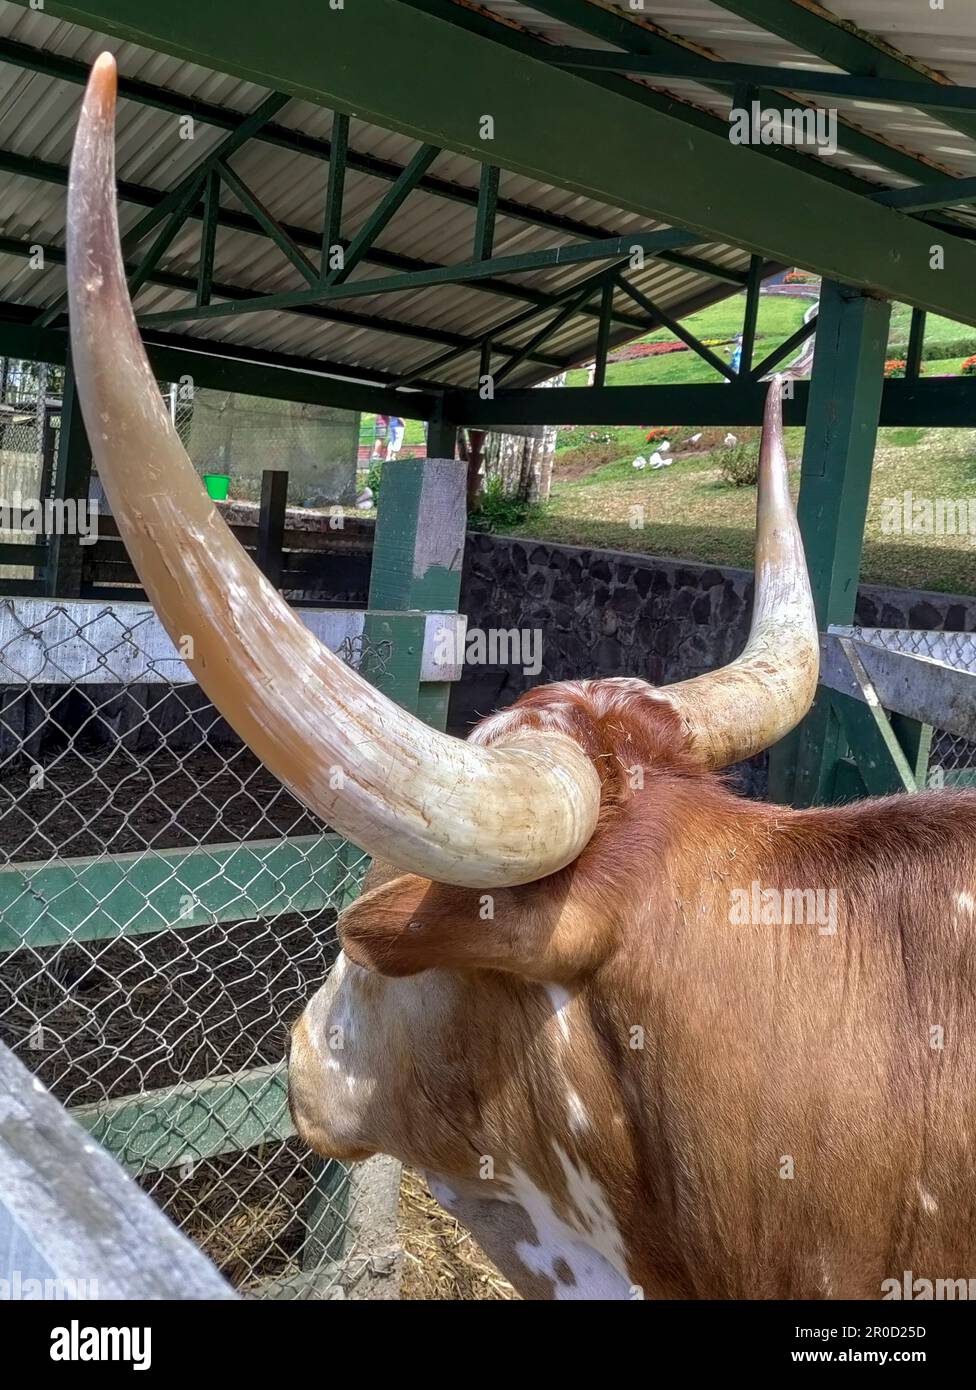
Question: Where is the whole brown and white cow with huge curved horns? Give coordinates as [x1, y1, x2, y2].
[68, 57, 976, 1298]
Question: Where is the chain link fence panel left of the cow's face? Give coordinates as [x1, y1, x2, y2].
[0, 599, 391, 1297]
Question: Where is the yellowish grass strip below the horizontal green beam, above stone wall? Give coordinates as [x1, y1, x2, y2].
[509, 428, 976, 594]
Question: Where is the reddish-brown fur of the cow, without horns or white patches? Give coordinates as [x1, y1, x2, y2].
[290, 681, 976, 1298]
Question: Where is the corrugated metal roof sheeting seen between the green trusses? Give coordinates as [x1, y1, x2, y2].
[0, 0, 976, 385]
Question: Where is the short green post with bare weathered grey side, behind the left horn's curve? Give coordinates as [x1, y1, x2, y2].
[366, 459, 467, 728]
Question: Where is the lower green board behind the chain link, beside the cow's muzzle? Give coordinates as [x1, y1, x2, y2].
[71, 1061, 295, 1176]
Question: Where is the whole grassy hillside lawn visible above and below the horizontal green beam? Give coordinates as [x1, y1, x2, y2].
[363, 293, 976, 594]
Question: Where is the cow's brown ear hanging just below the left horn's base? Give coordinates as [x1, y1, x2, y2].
[339, 874, 609, 984]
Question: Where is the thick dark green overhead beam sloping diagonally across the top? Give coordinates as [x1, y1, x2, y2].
[38, 0, 976, 322]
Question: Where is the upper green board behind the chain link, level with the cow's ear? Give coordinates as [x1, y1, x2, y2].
[0, 834, 364, 952]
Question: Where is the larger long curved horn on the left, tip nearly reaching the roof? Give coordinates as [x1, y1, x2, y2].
[68, 53, 599, 888]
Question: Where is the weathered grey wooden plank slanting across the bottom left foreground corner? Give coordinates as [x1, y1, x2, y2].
[0, 1044, 235, 1300]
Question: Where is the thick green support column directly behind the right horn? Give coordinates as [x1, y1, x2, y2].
[769, 281, 891, 806]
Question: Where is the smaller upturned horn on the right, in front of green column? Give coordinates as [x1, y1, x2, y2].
[660, 377, 820, 769]
